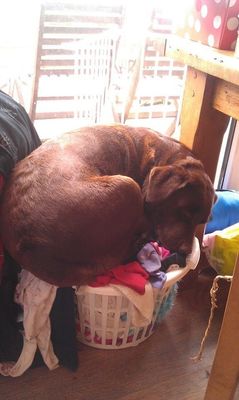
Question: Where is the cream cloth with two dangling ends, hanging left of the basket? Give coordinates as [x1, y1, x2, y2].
[0, 270, 58, 377]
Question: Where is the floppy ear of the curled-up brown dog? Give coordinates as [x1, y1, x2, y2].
[144, 164, 188, 203]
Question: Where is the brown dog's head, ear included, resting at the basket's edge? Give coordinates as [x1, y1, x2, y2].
[143, 157, 215, 254]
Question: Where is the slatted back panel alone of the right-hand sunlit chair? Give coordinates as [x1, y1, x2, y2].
[125, 36, 184, 118]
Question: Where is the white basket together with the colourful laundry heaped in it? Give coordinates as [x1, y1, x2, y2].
[76, 242, 186, 348]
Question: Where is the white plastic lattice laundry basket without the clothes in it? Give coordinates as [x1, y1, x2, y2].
[76, 238, 200, 349]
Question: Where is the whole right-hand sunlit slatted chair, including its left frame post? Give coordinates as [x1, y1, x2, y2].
[111, 9, 185, 135]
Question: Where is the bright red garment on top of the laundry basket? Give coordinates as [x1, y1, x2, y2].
[89, 261, 149, 294]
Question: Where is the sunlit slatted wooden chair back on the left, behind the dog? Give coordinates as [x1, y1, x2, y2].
[30, 1, 123, 132]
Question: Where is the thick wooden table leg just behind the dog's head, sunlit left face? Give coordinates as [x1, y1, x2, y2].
[180, 67, 229, 180]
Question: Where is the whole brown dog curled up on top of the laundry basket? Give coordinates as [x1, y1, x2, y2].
[1, 125, 214, 286]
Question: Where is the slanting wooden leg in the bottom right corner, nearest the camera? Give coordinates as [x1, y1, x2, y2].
[204, 257, 239, 400]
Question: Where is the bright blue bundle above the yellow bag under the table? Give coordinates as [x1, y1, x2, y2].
[205, 190, 239, 233]
